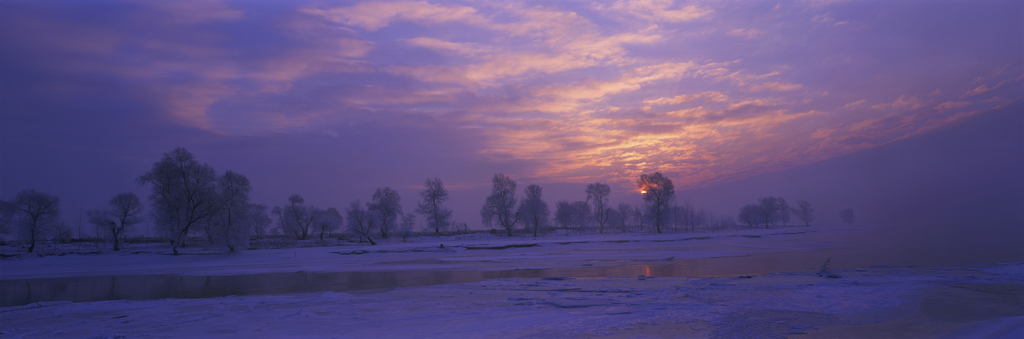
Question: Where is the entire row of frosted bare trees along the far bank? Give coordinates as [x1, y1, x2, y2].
[0, 147, 853, 253]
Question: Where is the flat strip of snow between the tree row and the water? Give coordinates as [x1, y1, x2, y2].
[2, 228, 842, 280]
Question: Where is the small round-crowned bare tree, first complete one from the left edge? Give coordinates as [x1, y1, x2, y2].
[13, 189, 60, 253]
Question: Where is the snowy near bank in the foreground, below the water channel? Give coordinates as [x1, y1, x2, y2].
[0, 263, 1024, 338]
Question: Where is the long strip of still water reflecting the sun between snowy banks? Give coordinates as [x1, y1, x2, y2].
[0, 225, 1024, 306]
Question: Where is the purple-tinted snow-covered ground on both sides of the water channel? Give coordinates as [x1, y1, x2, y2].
[0, 224, 1024, 338]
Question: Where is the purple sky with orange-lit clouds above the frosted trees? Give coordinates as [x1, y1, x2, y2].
[0, 0, 1024, 233]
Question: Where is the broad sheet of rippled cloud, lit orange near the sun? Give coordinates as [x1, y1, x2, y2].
[0, 1, 1024, 196]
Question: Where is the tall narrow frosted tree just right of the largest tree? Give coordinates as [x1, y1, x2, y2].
[214, 171, 253, 252]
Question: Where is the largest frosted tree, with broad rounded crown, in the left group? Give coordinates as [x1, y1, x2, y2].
[135, 147, 220, 254]
